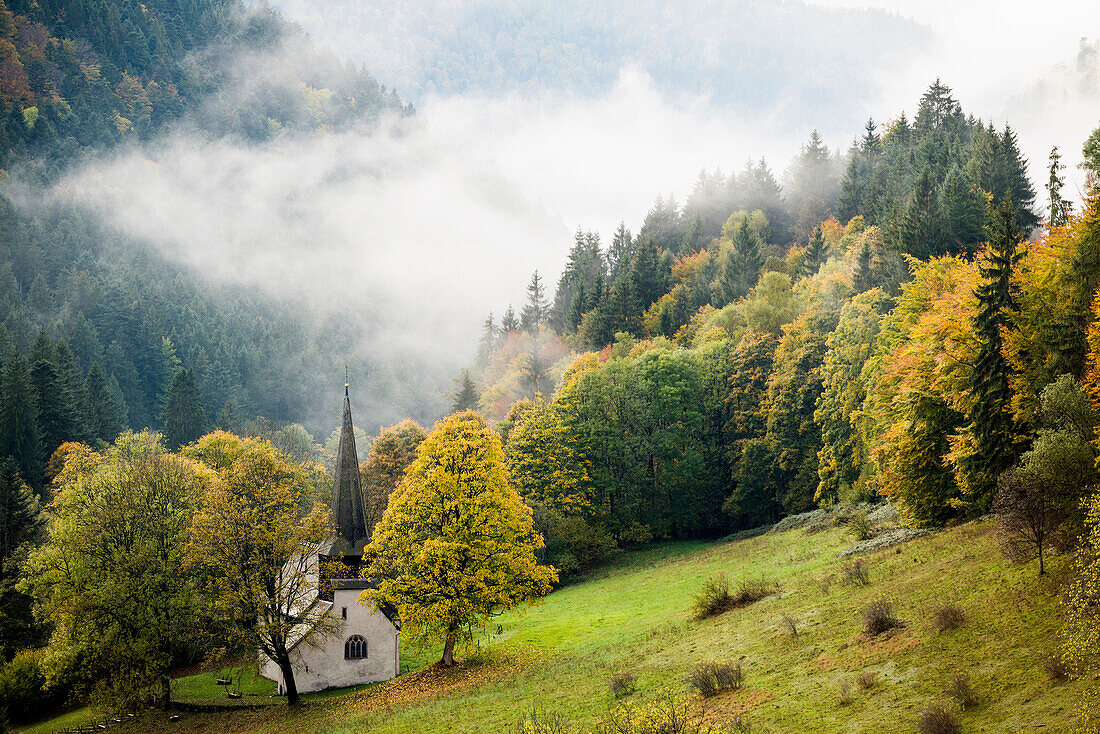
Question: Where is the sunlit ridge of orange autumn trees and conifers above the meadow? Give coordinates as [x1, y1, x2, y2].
[468, 80, 1100, 568]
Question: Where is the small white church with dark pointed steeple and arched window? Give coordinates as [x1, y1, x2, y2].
[260, 383, 402, 695]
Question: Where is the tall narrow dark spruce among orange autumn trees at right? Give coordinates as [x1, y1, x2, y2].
[963, 197, 1021, 514]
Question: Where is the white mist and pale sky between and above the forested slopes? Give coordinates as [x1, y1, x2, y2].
[53, 0, 1100, 418]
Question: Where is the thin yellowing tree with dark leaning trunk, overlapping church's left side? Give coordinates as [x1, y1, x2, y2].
[184, 432, 337, 706]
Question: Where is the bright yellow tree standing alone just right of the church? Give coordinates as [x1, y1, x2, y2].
[363, 410, 558, 666]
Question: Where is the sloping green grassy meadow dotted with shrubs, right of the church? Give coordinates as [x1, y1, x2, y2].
[81, 522, 1096, 733]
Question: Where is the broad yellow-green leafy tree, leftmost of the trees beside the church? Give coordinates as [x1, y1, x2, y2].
[28, 432, 211, 705]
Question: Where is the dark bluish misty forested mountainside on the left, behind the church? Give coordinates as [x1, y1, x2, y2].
[0, 0, 420, 486]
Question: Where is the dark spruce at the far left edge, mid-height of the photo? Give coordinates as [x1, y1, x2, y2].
[0, 353, 43, 489]
